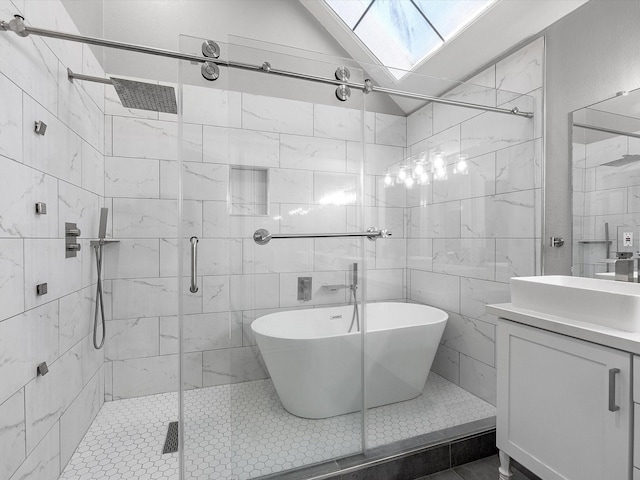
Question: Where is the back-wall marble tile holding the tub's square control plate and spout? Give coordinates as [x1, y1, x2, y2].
[280, 271, 346, 310]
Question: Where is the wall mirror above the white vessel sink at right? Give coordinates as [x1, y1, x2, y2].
[572, 89, 640, 281]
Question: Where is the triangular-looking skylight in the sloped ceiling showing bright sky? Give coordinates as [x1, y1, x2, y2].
[325, 0, 495, 80]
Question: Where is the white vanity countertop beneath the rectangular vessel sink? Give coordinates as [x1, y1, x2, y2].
[487, 303, 640, 355]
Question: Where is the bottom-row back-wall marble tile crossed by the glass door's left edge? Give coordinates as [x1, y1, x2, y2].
[113, 353, 202, 400]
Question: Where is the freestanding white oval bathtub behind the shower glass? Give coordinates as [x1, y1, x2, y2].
[251, 302, 449, 418]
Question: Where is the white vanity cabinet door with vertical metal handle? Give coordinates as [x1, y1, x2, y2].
[497, 319, 633, 480]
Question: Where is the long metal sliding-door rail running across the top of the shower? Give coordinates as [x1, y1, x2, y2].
[0, 15, 533, 118]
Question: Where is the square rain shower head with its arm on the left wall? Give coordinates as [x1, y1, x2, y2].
[67, 68, 178, 114]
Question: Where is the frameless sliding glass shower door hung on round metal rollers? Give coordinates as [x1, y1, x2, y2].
[176, 36, 372, 479]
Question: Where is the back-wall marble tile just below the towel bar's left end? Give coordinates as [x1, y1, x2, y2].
[242, 238, 313, 275]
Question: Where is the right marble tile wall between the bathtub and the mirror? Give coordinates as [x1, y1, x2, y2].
[406, 38, 544, 404]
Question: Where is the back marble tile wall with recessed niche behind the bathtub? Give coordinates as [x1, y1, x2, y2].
[104, 74, 407, 399]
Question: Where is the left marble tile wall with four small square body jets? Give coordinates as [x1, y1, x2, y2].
[0, 0, 104, 480]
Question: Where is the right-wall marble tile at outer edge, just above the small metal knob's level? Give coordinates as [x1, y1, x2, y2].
[460, 190, 535, 238]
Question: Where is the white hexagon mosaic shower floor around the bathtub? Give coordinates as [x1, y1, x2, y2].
[60, 373, 495, 480]
